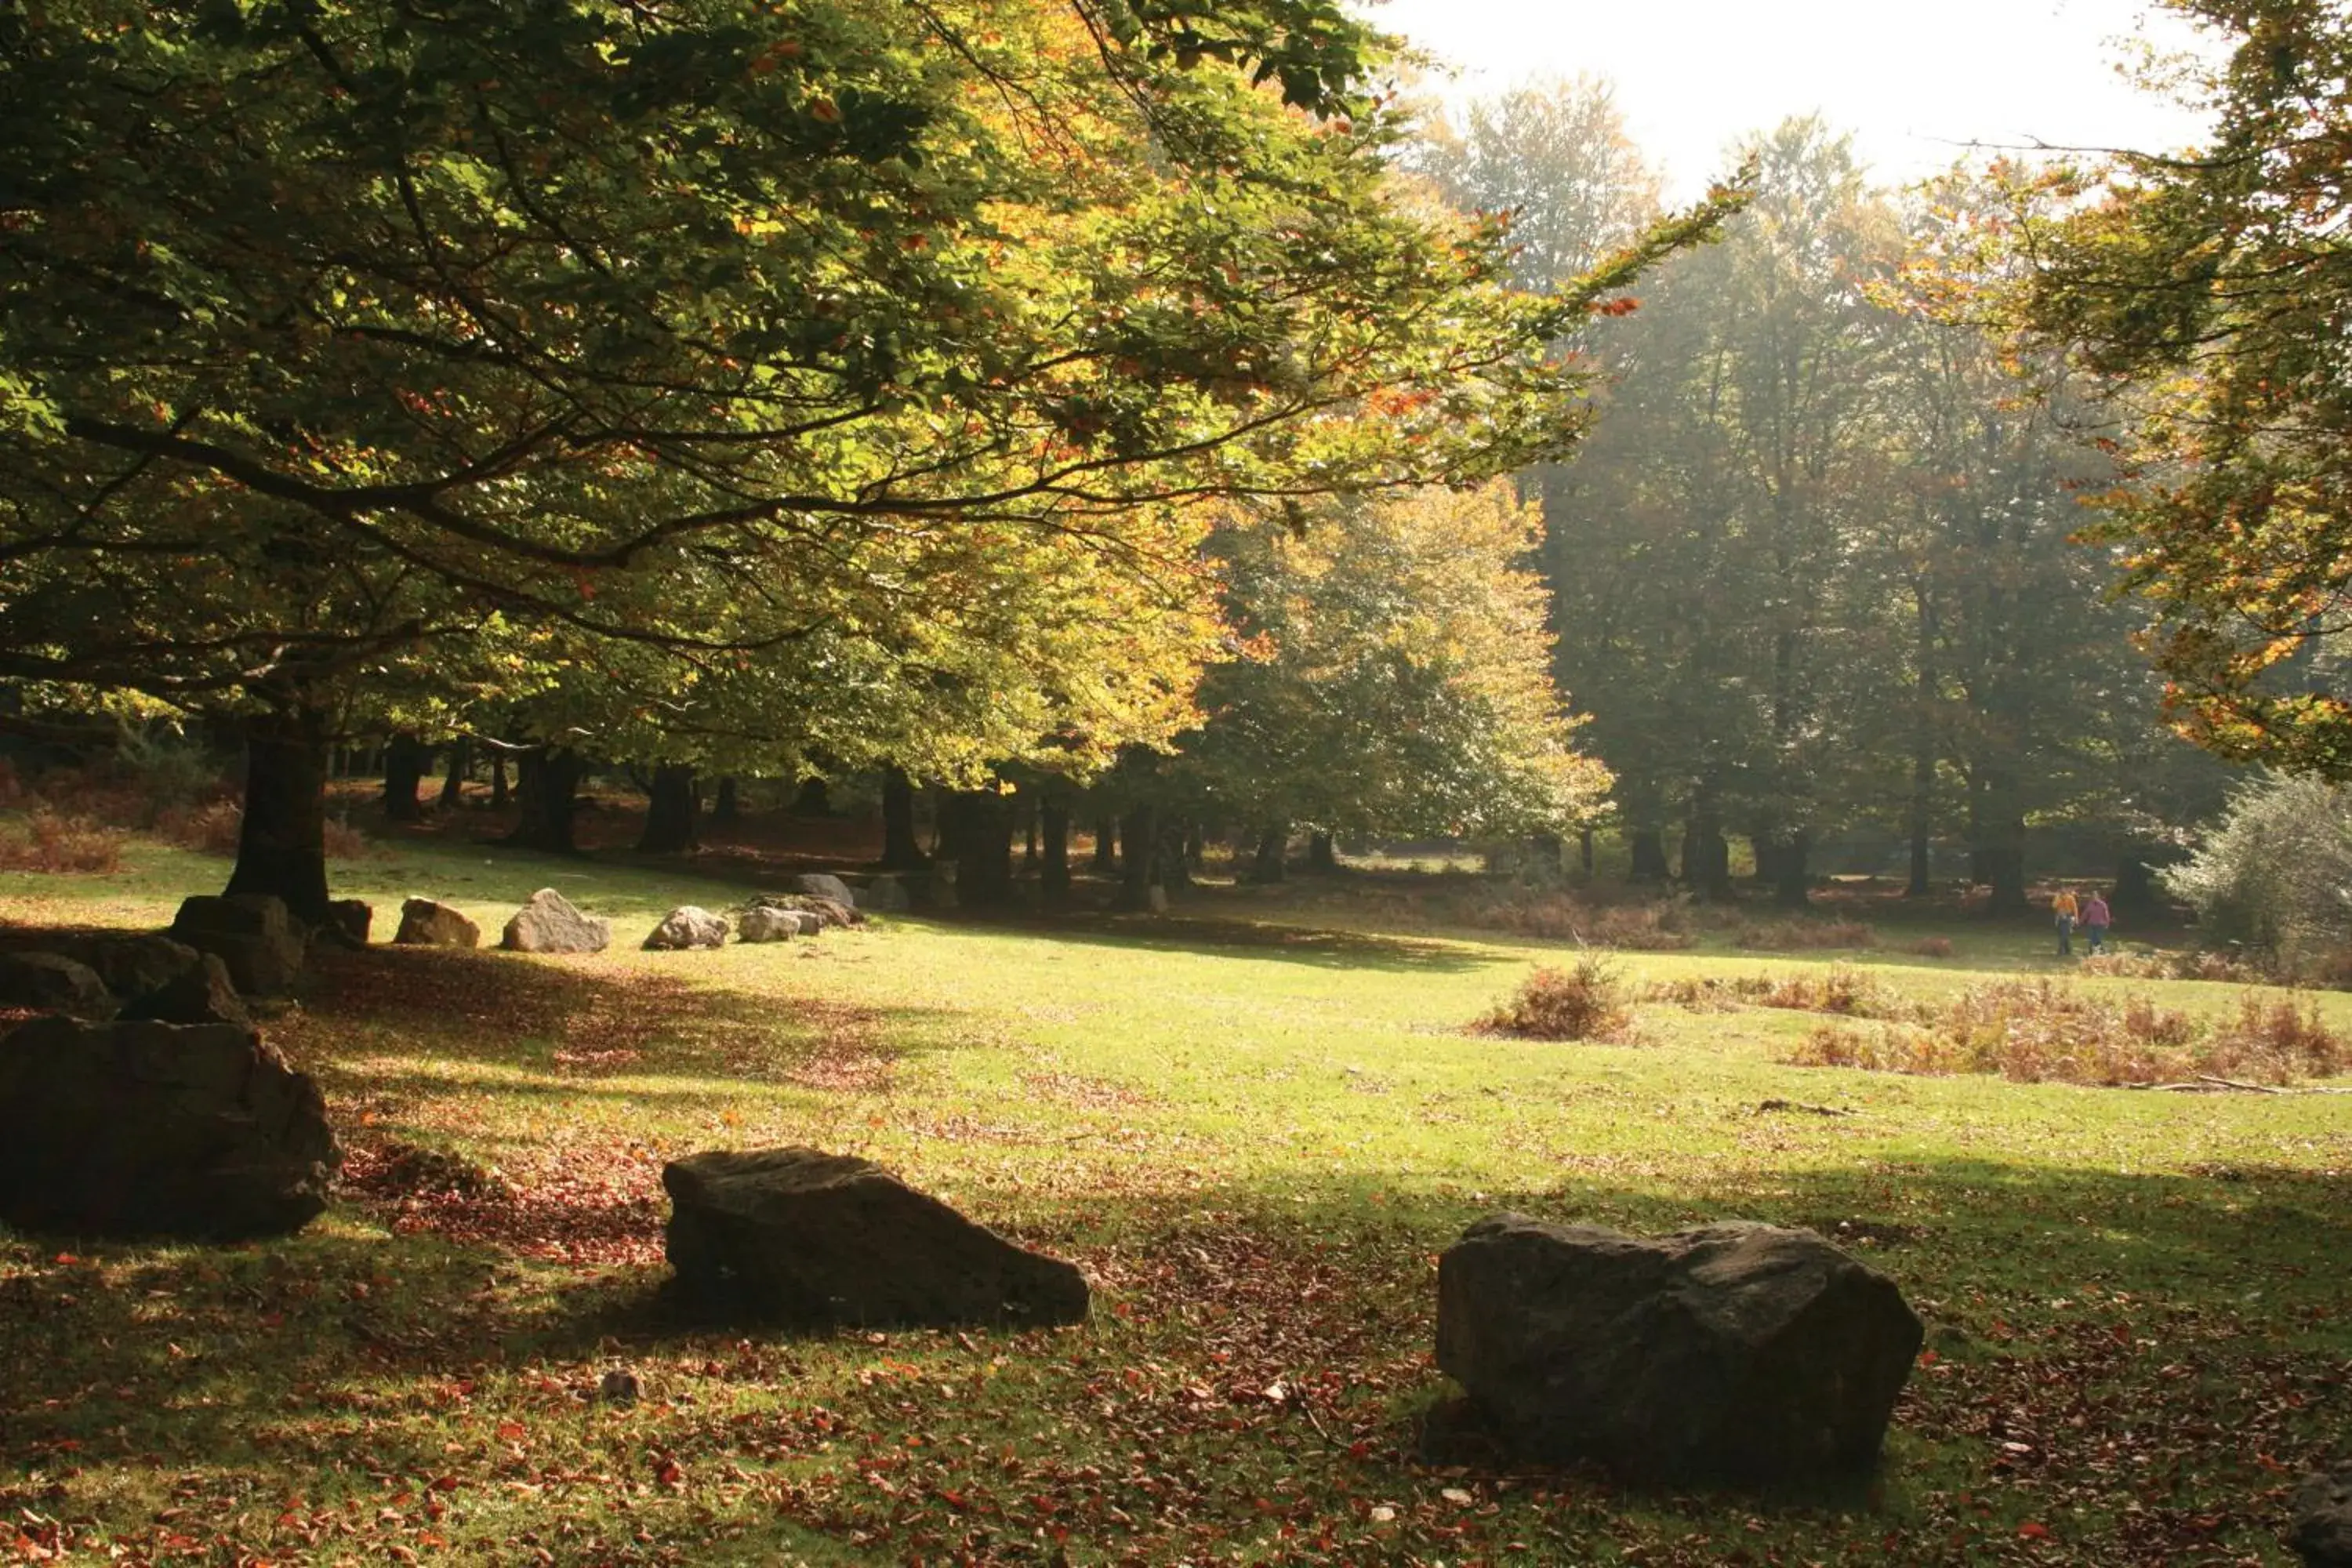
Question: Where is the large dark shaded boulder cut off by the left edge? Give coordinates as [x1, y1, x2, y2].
[0, 1018, 341, 1241]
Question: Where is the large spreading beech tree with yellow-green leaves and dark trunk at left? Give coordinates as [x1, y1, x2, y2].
[0, 0, 1717, 916]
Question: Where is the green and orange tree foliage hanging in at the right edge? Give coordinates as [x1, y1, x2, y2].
[2020, 0, 2352, 779]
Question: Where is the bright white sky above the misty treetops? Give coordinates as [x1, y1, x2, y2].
[1367, 0, 2204, 200]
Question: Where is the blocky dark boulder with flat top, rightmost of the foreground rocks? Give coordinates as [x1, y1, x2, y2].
[1437, 1213, 1922, 1481]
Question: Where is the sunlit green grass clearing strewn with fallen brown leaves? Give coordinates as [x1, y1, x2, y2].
[0, 841, 2352, 1568]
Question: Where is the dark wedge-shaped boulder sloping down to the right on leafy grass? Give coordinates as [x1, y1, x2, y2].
[661, 1149, 1087, 1328]
